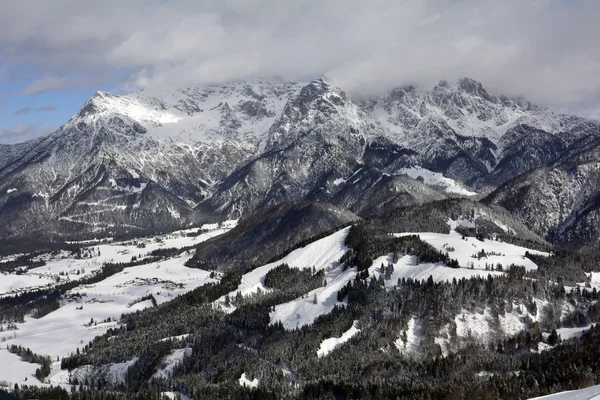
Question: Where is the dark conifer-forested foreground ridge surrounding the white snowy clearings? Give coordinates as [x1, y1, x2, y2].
[2, 201, 600, 399]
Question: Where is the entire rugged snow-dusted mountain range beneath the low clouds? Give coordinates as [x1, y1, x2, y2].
[0, 78, 600, 241]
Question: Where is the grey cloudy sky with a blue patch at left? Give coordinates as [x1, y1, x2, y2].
[0, 0, 600, 143]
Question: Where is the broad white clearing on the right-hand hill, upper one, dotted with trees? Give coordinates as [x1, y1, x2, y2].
[395, 230, 550, 271]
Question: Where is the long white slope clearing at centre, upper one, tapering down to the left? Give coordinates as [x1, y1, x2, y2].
[215, 228, 350, 311]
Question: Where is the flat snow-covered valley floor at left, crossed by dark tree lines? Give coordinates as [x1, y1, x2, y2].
[0, 222, 235, 385]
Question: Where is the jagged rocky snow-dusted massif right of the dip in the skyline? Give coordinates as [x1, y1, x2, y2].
[361, 78, 600, 188]
